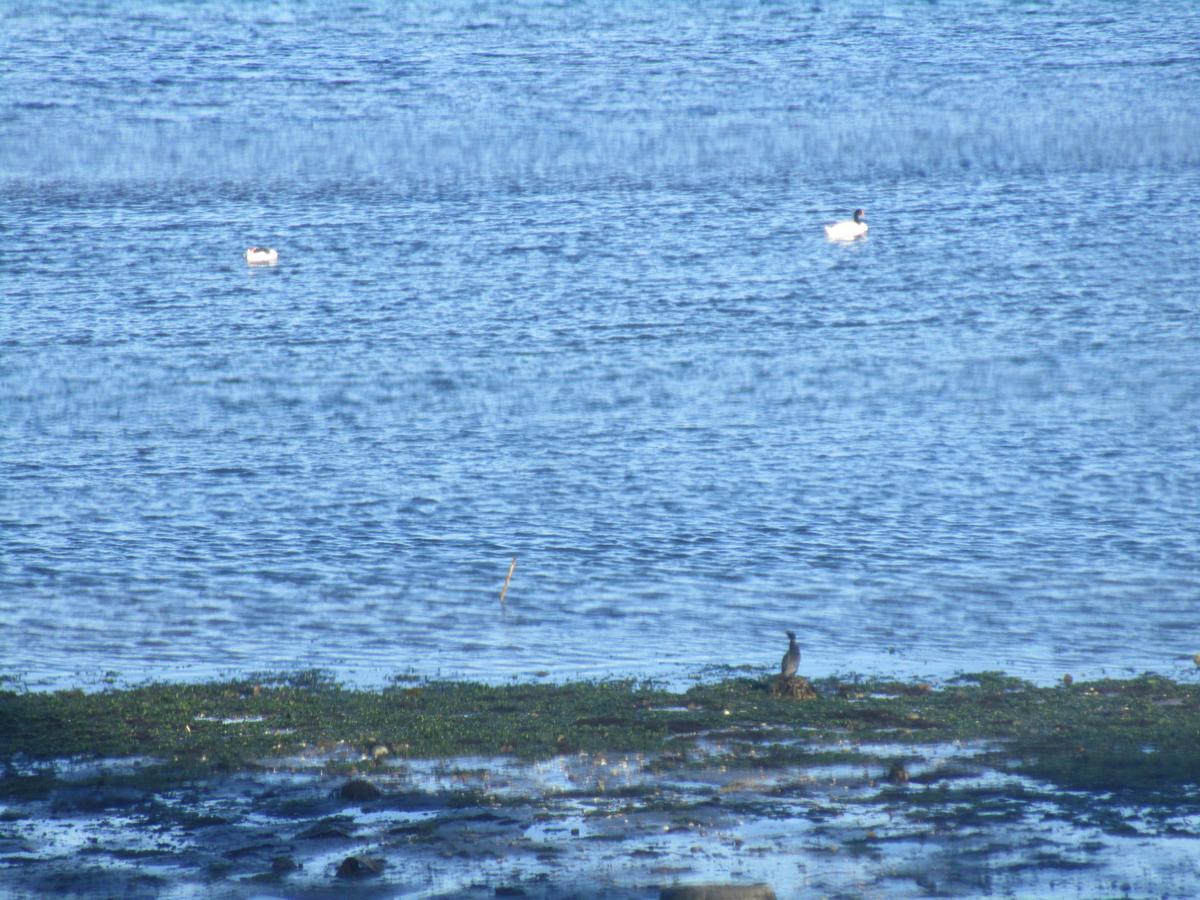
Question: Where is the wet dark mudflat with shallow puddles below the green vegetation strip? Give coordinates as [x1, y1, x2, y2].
[11, 746, 1200, 898]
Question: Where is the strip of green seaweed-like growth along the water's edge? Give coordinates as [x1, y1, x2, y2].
[0, 673, 1200, 791]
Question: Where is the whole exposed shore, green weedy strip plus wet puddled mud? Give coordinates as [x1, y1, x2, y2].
[0, 670, 1200, 898]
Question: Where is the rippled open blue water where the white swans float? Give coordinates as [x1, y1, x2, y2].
[0, 1, 1200, 684]
